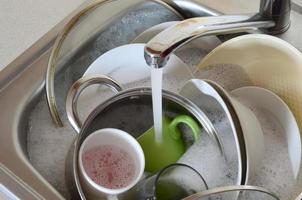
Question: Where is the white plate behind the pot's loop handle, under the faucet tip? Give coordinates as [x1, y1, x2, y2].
[78, 44, 192, 119]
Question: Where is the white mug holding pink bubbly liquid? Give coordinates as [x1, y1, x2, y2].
[78, 128, 145, 199]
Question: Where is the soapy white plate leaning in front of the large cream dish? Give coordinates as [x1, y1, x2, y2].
[232, 88, 301, 200]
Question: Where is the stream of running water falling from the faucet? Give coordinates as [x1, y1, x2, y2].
[151, 67, 163, 143]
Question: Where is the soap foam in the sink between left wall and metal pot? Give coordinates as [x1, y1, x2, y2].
[27, 95, 76, 197]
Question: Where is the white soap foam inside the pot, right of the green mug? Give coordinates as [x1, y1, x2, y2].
[179, 112, 238, 188]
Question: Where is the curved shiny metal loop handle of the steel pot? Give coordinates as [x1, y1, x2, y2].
[66, 74, 122, 133]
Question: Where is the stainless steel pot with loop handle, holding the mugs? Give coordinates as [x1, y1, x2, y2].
[66, 75, 222, 199]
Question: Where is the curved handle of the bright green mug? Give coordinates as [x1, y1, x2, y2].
[169, 115, 201, 141]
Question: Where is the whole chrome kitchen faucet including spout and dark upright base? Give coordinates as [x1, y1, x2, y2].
[144, 0, 291, 68]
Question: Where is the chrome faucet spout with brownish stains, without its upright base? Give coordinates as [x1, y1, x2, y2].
[145, 16, 275, 68]
